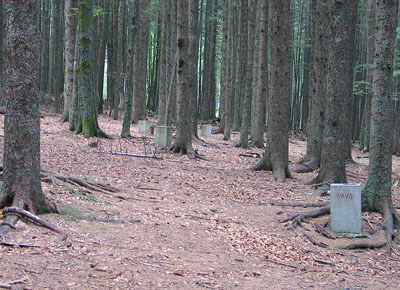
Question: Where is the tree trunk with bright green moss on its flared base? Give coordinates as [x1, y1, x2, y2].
[75, 0, 109, 137]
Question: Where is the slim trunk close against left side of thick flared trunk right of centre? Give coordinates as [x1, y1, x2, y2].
[252, 0, 268, 148]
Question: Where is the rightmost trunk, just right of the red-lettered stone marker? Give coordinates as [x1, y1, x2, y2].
[362, 0, 400, 250]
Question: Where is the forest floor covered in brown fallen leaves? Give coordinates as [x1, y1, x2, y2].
[0, 115, 400, 289]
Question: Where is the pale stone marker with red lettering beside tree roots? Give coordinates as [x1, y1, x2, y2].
[330, 183, 361, 234]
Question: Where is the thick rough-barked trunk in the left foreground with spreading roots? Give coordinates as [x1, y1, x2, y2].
[0, 0, 57, 234]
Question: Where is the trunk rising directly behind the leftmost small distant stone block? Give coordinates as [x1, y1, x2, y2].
[132, 0, 150, 123]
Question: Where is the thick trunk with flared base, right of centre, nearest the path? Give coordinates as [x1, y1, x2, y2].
[253, 0, 292, 181]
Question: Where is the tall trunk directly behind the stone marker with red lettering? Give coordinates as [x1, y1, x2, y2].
[316, 0, 357, 183]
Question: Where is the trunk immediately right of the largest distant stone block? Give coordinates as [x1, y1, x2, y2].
[171, 0, 192, 154]
